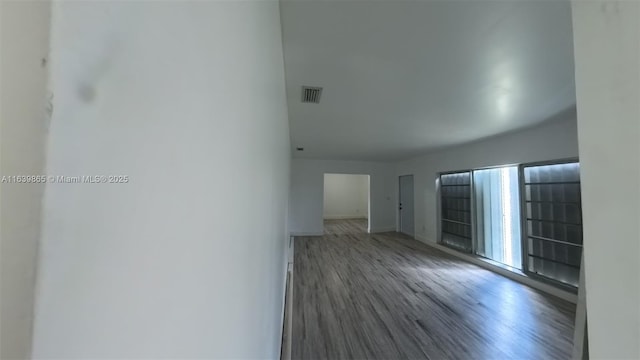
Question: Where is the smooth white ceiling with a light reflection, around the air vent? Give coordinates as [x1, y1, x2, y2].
[281, 0, 575, 161]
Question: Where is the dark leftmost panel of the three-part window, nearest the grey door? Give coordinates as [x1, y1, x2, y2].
[440, 171, 472, 252]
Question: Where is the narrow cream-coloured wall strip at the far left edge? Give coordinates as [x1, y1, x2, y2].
[0, 1, 51, 359]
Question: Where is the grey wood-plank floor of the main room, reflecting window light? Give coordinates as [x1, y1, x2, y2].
[292, 221, 575, 359]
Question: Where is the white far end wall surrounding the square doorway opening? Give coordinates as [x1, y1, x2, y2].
[289, 159, 398, 235]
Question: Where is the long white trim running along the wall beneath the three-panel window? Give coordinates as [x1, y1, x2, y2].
[416, 237, 578, 304]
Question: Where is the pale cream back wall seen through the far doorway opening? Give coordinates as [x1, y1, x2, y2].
[323, 174, 369, 219]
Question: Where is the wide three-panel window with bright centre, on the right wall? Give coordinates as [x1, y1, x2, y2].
[439, 162, 582, 288]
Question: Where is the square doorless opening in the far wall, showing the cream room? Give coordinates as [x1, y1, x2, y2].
[322, 174, 371, 235]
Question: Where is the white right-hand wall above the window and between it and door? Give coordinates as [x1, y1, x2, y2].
[397, 109, 578, 242]
